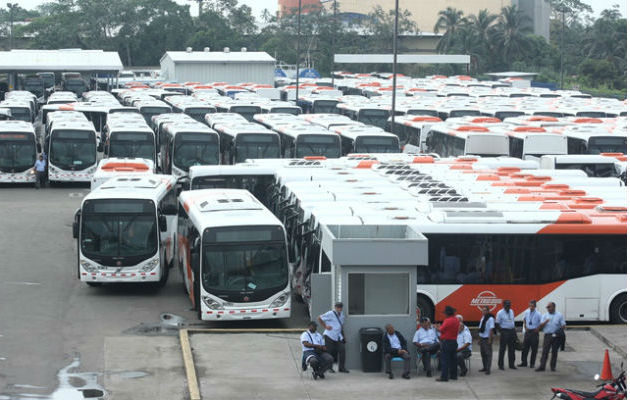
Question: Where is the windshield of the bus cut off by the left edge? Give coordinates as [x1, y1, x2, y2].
[0, 133, 36, 172]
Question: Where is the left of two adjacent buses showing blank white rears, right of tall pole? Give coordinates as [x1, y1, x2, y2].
[426, 124, 510, 157]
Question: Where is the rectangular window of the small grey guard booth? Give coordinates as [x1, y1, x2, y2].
[348, 272, 409, 315]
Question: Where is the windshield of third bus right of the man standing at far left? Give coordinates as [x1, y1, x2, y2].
[173, 132, 219, 171]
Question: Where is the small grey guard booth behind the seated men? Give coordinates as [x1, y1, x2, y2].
[311, 225, 428, 369]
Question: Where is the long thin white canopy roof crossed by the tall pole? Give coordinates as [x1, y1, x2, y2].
[335, 54, 470, 64]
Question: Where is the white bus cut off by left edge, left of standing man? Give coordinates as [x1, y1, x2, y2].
[0, 120, 39, 183]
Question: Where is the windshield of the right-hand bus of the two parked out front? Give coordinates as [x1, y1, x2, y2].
[201, 226, 288, 302]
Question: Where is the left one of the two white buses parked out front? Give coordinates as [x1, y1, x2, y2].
[72, 175, 177, 286]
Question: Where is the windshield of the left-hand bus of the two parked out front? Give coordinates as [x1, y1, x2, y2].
[80, 199, 158, 266]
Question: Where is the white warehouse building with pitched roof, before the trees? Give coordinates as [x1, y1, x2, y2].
[160, 48, 276, 85]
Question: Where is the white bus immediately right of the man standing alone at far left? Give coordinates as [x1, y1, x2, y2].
[45, 120, 97, 183]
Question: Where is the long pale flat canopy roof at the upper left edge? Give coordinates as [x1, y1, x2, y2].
[0, 49, 123, 72]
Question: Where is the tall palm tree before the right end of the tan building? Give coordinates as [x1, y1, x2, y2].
[496, 5, 532, 69]
